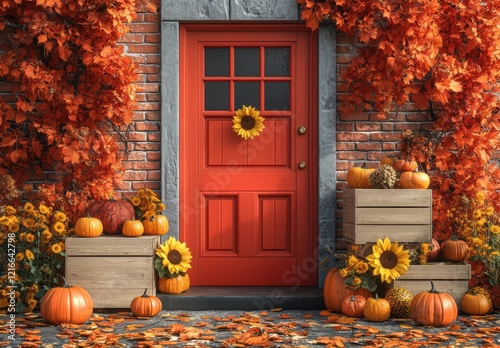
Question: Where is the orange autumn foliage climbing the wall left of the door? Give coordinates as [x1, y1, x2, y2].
[0, 0, 155, 222]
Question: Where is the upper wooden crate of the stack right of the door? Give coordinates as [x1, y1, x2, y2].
[343, 189, 432, 244]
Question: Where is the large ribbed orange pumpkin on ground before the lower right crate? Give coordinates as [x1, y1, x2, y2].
[410, 280, 458, 326]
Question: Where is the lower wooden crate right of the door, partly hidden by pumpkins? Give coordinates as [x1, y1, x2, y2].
[394, 262, 471, 307]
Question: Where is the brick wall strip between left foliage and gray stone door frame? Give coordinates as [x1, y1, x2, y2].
[118, 4, 161, 196]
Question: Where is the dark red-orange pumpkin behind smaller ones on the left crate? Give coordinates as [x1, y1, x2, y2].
[87, 199, 135, 234]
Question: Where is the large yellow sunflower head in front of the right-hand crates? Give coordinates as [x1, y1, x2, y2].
[366, 237, 410, 283]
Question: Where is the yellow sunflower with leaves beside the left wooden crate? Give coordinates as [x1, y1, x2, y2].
[155, 236, 192, 278]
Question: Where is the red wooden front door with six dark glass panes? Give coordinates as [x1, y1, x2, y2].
[180, 24, 317, 286]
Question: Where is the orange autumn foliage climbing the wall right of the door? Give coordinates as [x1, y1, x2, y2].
[297, 0, 500, 300]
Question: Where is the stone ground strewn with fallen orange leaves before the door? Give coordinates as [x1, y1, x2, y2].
[0, 310, 500, 347]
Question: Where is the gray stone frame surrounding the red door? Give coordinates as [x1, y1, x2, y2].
[161, 0, 336, 287]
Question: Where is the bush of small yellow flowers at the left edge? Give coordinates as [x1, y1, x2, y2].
[0, 202, 69, 313]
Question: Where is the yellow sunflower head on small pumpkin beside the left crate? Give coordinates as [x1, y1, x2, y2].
[156, 236, 191, 276]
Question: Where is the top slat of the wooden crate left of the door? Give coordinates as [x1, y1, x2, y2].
[66, 235, 159, 256]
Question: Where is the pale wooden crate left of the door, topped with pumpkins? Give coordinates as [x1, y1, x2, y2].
[66, 235, 160, 308]
